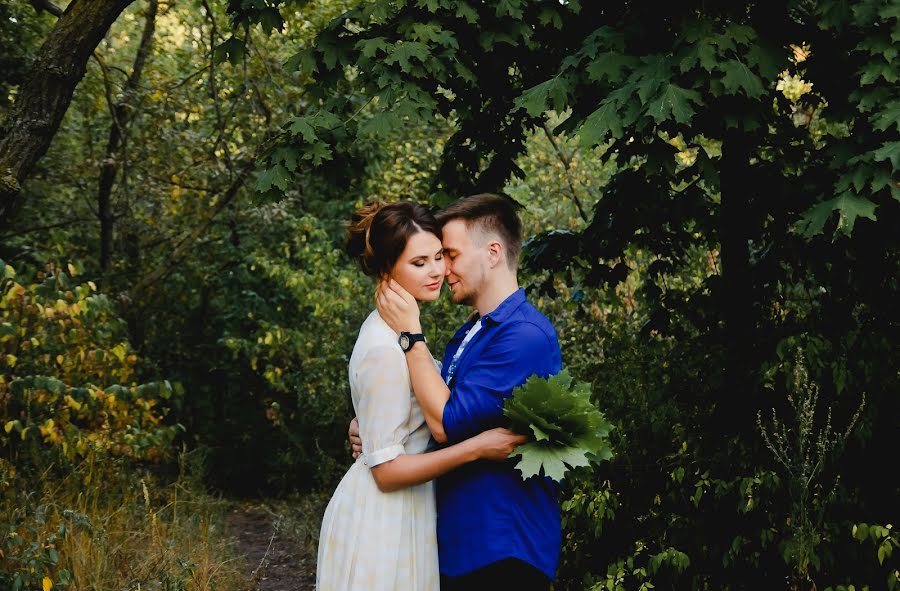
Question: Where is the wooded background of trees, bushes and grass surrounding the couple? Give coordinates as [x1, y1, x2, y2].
[0, 0, 900, 591]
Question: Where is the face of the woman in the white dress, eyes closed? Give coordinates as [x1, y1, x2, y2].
[391, 231, 446, 302]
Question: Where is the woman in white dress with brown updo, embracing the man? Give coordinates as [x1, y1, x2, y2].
[316, 201, 526, 591]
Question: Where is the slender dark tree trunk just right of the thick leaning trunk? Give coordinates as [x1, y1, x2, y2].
[97, 0, 159, 272]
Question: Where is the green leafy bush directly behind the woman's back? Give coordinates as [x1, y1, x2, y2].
[212, 205, 373, 490]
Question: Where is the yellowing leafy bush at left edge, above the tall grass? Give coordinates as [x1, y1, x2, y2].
[0, 261, 178, 474]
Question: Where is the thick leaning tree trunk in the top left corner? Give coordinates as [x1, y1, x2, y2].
[0, 0, 134, 226]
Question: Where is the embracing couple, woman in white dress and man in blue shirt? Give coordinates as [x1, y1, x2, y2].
[316, 194, 561, 591]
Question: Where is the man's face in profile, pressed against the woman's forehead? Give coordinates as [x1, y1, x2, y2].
[441, 220, 488, 306]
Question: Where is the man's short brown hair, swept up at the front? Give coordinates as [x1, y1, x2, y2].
[434, 193, 522, 269]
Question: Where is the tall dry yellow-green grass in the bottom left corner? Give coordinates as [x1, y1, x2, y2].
[0, 452, 248, 591]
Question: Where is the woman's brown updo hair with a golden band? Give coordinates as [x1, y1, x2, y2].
[347, 201, 441, 277]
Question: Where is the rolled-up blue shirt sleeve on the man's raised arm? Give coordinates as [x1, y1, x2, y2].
[442, 322, 561, 443]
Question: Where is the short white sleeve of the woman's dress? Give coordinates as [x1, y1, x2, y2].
[357, 347, 412, 468]
